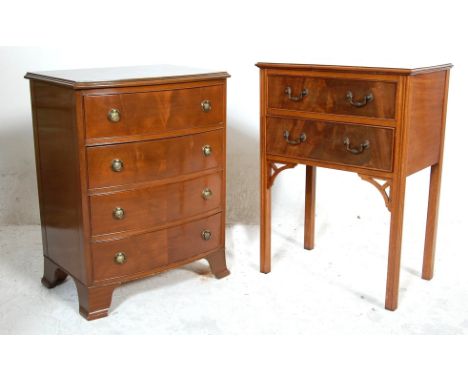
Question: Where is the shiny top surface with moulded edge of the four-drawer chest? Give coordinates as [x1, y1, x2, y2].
[25, 65, 230, 89]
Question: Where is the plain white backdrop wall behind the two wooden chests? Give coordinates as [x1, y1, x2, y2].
[0, 0, 468, 231]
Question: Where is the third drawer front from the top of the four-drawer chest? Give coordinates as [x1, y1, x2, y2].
[90, 172, 223, 235]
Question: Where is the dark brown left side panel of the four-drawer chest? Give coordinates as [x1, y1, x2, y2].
[31, 81, 85, 280]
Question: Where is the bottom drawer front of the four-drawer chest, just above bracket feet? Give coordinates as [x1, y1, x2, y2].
[92, 214, 222, 281]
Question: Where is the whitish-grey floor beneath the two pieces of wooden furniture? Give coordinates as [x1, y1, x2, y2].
[0, 216, 468, 334]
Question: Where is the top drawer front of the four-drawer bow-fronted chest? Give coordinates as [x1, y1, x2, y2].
[84, 85, 224, 139]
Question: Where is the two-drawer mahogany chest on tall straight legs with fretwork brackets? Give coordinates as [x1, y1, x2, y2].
[257, 63, 452, 310]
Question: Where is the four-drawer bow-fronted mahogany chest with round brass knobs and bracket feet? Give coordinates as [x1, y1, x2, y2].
[26, 65, 229, 320]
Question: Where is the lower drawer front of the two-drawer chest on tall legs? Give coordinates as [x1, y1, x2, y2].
[267, 118, 394, 171]
